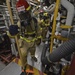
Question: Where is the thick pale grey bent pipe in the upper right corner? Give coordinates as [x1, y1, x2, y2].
[61, 0, 74, 25]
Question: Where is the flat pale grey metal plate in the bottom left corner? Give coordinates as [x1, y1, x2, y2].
[0, 62, 21, 75]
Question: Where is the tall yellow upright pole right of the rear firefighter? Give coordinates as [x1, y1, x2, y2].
[50, 0, 60, 53]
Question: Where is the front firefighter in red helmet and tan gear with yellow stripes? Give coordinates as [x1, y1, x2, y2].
[16, 0, 41, 73]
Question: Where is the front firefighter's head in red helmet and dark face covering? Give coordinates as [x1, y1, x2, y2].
[16, 0, 30, 20]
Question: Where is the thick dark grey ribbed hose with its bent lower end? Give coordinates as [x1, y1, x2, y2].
[41, 39, 75, 64]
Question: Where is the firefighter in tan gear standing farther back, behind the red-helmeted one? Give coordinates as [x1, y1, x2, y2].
[38, 11, 50, 42]
